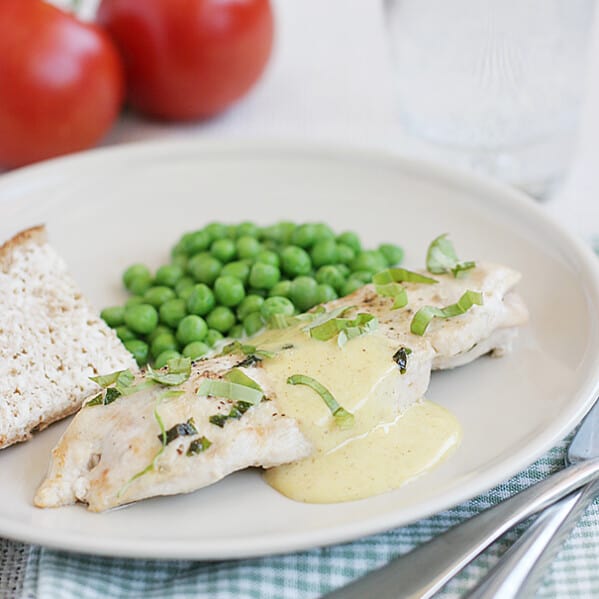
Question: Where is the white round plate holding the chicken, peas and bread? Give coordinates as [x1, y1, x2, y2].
[0, 143, 599, 559]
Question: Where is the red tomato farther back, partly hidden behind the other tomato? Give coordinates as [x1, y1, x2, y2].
[98, 0, 273, 120]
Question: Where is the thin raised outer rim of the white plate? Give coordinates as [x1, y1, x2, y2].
[0, 138, 599, 560]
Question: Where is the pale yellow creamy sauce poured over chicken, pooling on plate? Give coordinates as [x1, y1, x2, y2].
[252, 323, 461, 503]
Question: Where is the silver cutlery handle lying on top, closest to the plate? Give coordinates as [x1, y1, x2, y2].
[323, 459, 599, 599]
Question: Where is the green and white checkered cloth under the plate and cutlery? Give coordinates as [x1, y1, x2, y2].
[0, 439, 599, 599]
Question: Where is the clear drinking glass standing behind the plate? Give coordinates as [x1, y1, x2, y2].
[385, 0, 595, 195]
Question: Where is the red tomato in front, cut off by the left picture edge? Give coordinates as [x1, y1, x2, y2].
[0, 0, 124, 167]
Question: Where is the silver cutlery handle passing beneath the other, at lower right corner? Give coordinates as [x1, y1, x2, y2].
[467, 482, 599, 599]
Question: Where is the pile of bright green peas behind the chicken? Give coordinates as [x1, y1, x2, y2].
[101, 222, 403, 368]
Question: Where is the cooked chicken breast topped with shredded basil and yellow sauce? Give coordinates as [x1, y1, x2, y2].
[34, 264, 528, 511]
